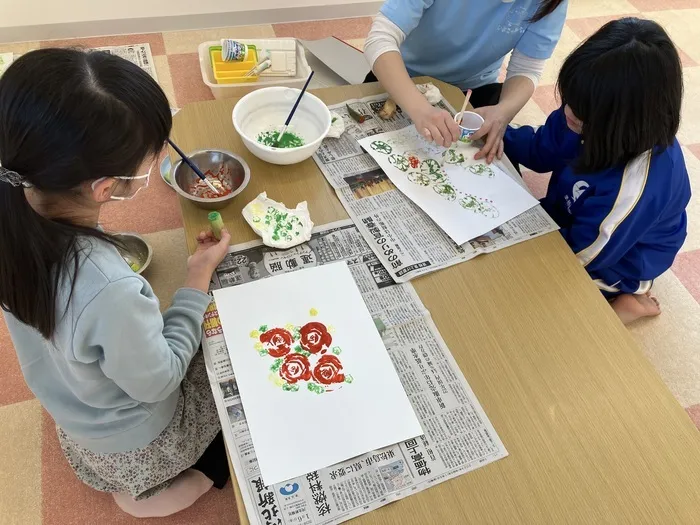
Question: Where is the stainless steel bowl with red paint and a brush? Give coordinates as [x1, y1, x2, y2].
[171, 149, 250, 210]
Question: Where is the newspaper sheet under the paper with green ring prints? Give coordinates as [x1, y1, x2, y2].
[314, 94, 558, 282]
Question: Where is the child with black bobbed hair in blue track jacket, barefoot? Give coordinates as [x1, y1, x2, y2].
[505, 18, 691, 324]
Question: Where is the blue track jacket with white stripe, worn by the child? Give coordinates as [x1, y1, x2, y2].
[504, 108, 691, 297]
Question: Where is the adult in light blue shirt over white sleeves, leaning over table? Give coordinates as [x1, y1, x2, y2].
[365, 0, 568, 162]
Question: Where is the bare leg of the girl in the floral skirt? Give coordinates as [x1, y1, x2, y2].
[112, 469, 214, 518]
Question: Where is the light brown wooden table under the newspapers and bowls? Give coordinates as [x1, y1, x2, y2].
[173, 79, 700, 525]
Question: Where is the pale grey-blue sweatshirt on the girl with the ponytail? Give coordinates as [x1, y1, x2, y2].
[5, 240, 210, 453]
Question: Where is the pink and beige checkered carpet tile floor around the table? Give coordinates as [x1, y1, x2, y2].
[0, 6, 700, 525]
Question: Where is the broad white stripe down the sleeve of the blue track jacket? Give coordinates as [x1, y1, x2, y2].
[576, 150, 651, 266]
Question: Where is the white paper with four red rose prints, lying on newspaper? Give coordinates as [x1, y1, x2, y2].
[214, 262, 423, 485]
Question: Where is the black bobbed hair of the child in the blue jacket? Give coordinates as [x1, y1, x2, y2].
[557, 18, 683, 172]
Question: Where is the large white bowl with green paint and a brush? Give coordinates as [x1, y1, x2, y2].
[232, 87, 331, 164]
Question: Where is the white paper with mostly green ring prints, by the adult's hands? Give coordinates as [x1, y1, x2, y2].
[359, 126, 538, 245]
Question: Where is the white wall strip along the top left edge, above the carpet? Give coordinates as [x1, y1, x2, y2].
[0, 0, 381, 42]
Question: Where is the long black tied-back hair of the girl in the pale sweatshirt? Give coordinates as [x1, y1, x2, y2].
[0, 49, 172, 339]
